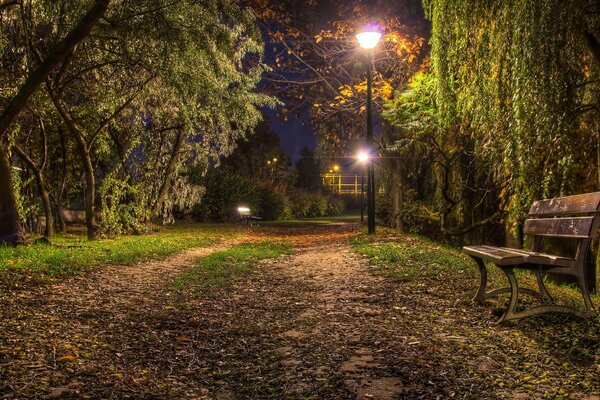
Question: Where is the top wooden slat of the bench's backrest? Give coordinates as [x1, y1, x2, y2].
[529, 192, 600, 217]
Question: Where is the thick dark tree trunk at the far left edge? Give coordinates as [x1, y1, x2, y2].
[0, 145, 24, 242]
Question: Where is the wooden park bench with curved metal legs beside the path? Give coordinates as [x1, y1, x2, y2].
[463, 192, 600, 323]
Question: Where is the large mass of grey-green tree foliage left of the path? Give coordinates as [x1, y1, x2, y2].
[0, 0, 277, 236]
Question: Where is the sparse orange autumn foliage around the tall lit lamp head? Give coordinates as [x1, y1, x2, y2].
[246, 0, 426, 155]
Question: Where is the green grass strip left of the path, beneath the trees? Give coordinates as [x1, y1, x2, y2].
[0, 224, 238, 283]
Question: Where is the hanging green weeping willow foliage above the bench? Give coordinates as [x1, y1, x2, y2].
[423, 0, 600, 241]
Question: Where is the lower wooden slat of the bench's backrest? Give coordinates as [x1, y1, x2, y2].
[523, 216, 595, 239]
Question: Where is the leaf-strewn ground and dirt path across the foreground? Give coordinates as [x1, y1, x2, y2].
[0, 220, 600, 399]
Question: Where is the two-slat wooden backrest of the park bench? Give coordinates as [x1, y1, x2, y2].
[523, 192, 600, 239]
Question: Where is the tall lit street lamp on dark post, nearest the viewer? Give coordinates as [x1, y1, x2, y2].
[356, 31, 381, 234]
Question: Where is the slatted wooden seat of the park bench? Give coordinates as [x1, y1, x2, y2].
[463, 245, 575, 267]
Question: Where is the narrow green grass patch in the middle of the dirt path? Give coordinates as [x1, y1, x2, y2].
[172, 241, 291, 291]
